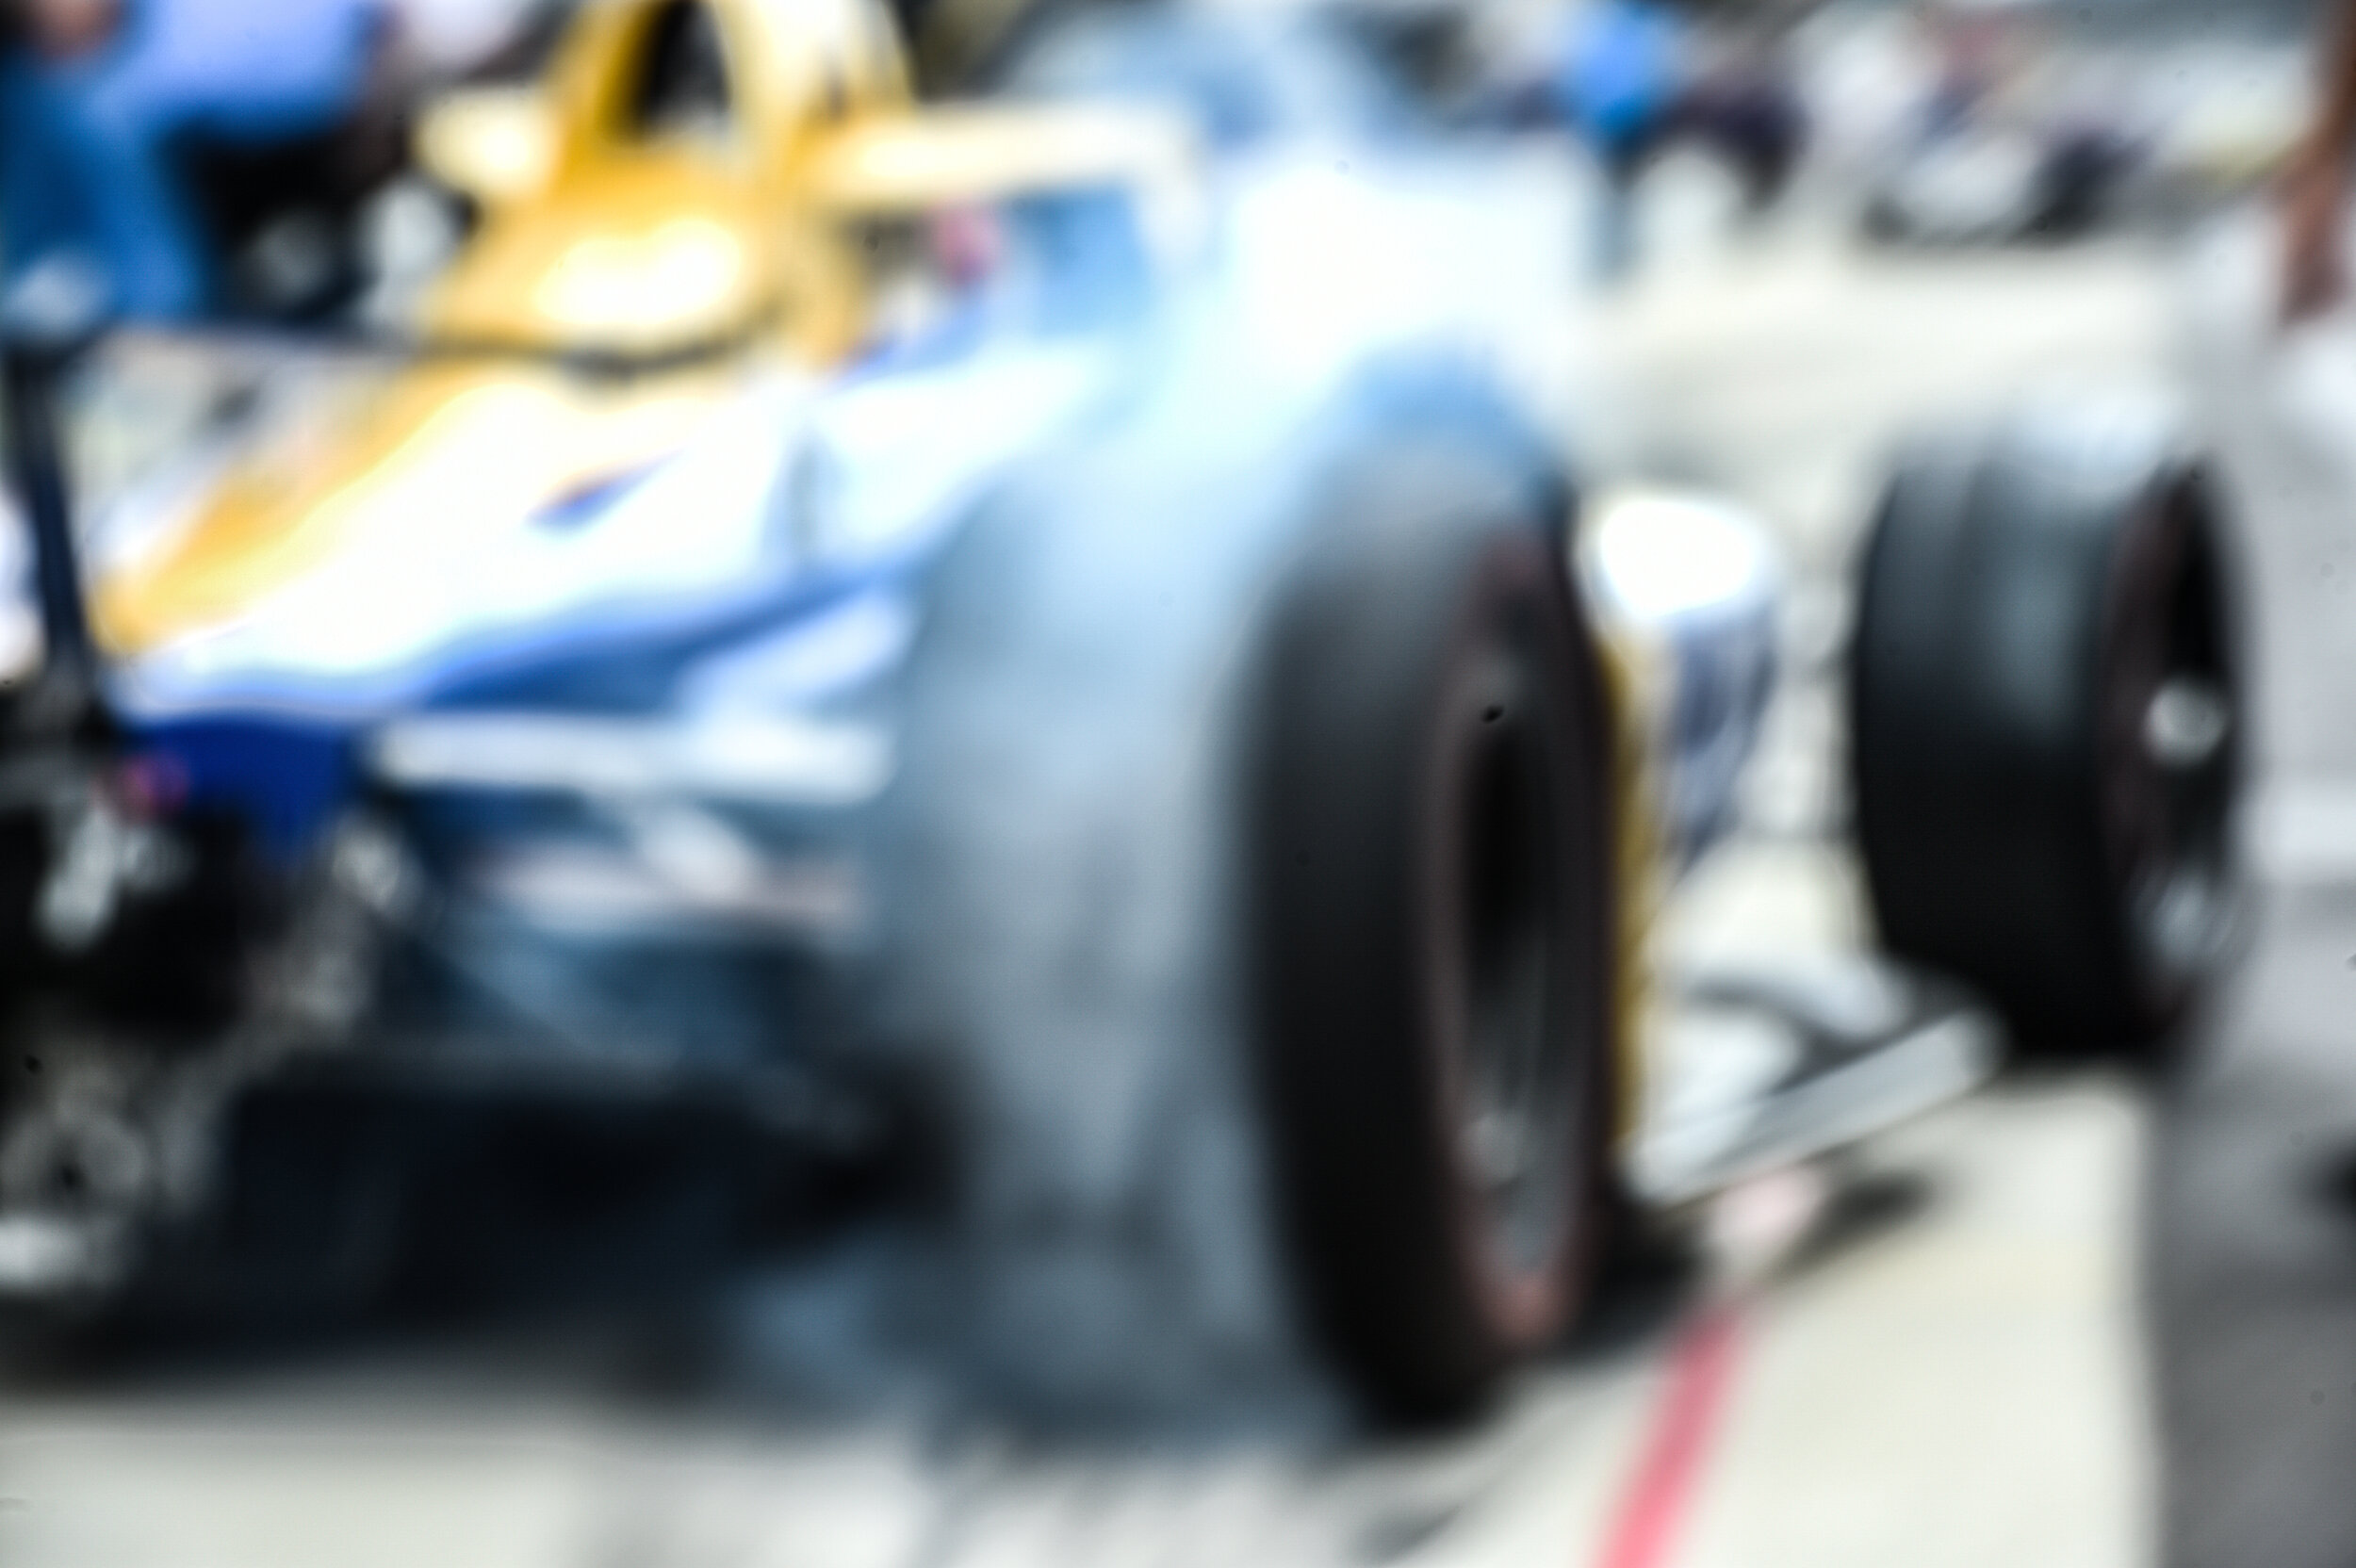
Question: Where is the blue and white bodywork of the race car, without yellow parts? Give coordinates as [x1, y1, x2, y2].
[0, 33, 1776, 1318]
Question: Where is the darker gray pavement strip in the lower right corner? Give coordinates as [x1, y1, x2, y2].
[2147, 890, 2356, 1568]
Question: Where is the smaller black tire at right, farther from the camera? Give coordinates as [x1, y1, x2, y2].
[1850, 407, 2241, 1057]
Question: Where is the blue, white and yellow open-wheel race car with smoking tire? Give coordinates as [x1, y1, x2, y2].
[0, 0, 2232, 1420]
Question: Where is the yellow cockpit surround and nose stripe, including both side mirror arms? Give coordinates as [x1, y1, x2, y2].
[97, 0, 1186, 655]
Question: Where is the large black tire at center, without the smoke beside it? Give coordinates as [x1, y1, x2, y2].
[1249, 440, 1614, 1417]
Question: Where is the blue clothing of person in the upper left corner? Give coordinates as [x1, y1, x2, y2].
[0, 0, 384, 318]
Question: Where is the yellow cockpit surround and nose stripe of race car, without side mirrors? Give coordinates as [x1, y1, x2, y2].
[97, 0, 908, 655]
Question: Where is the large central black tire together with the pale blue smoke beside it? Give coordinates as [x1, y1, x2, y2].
[879, 398, 1616, 1420]
